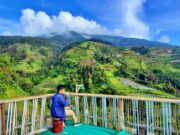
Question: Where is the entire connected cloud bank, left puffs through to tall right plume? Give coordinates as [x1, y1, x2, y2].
[0, 0, 151, 39]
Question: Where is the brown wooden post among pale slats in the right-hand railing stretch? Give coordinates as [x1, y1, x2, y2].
[118, 98, 123, 131]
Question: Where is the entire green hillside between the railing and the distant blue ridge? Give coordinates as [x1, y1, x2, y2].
[0, 37, 180, 98]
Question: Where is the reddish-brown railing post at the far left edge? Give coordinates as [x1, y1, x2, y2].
[0, 103, 6, 135]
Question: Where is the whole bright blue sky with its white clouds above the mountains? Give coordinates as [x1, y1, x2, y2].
[0, 0, 180, 45]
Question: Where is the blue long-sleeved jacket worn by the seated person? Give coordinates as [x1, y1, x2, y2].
[51, 93, 69, 120]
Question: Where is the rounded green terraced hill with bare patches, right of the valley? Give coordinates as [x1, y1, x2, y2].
[35, 42, 180, 97]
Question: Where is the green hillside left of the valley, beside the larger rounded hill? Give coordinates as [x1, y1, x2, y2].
[0, 44, 54, 97]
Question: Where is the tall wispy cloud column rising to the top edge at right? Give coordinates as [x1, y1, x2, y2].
[120, 0, 151, 39]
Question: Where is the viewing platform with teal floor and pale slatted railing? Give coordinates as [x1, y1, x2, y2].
[0, 93, 180, 135]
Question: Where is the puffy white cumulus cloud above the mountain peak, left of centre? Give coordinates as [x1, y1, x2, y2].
[20, 9, 107, 36]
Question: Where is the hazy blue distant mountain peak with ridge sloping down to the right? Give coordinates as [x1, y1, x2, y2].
[41, 31, 174, 47]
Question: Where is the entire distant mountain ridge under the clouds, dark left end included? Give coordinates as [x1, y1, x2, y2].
[0, 31, 174, 47]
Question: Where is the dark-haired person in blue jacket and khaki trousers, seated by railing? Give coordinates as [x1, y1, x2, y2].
[51, 85, 78, 133]
